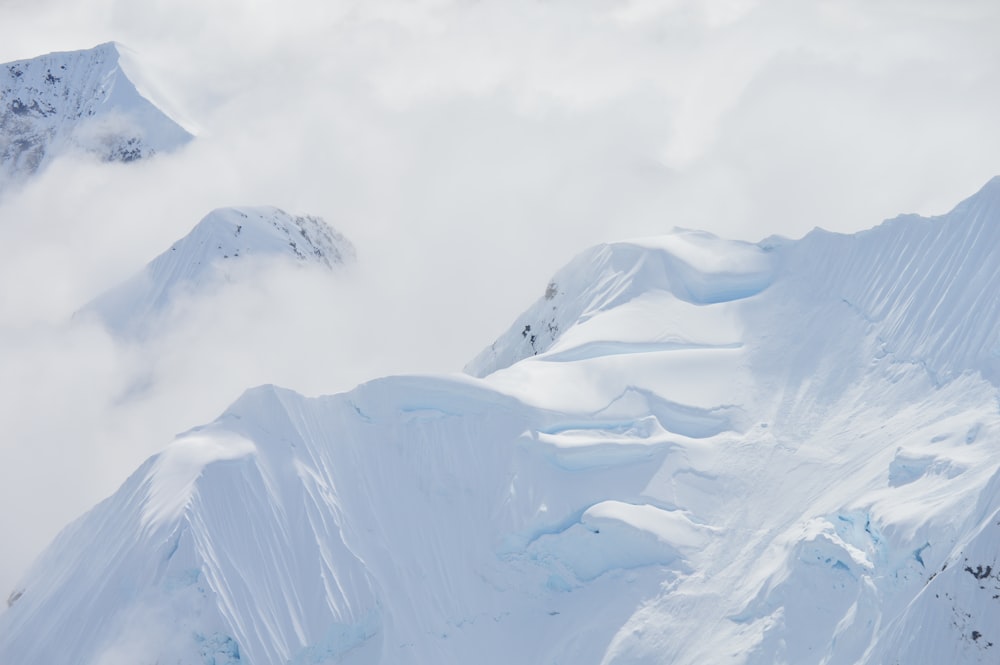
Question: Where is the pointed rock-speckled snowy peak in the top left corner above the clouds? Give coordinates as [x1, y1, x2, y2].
[0, 43, 191, 188]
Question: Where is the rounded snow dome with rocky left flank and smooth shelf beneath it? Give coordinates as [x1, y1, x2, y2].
[466, 231, 774, 377]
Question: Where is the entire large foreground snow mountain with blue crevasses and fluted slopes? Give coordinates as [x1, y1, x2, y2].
[0, 181, 1000, 665]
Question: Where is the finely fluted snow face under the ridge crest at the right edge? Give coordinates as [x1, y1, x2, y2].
[788, 177, 1000, 383]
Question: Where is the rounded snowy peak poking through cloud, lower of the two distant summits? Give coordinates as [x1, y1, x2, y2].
[83, 206, 355, 337]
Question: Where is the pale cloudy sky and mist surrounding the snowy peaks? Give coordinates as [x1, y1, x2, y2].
[0, 0, 1000, 593]
